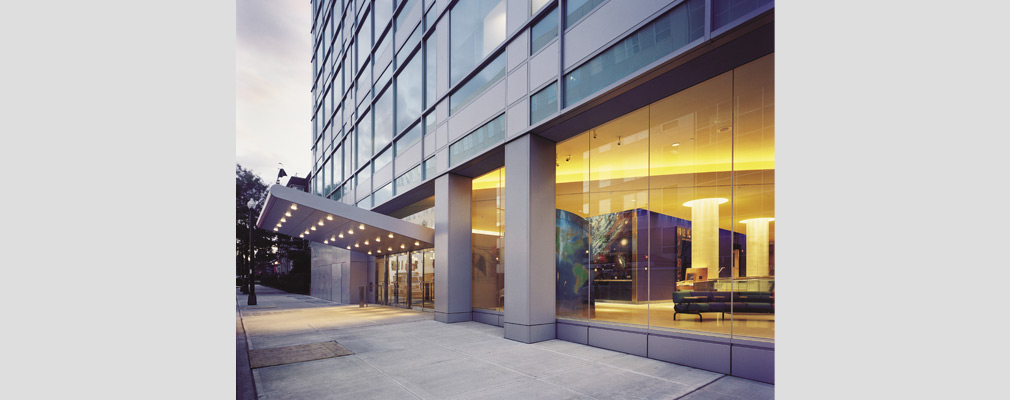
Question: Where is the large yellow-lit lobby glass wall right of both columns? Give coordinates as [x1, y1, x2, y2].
[553, 55, 775, 339]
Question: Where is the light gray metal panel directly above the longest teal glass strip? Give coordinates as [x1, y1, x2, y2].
[565, 0, 673, 70]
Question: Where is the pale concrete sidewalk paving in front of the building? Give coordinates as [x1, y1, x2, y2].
[236, 286, 775, 400]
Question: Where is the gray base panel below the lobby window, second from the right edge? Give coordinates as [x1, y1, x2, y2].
[648, 334, 730, 374]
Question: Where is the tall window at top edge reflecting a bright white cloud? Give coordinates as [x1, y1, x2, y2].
[448, 0, 505, 86]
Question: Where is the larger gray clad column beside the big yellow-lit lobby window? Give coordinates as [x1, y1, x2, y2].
[505, 134, 557, 343]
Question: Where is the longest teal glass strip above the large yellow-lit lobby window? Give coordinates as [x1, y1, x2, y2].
[565, 0, 705, 107]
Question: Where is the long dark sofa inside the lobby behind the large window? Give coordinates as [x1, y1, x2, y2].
[674, 291, 775, 321]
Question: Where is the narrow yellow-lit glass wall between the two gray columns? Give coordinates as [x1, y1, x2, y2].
[471, 168, 505, 311]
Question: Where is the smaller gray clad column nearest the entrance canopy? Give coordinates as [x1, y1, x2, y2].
[434, 174, 474, 322]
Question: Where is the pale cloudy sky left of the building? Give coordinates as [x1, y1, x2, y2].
[235, 0, 312, 184]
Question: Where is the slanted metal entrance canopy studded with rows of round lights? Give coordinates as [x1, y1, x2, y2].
[257, 185, 435, 256]
